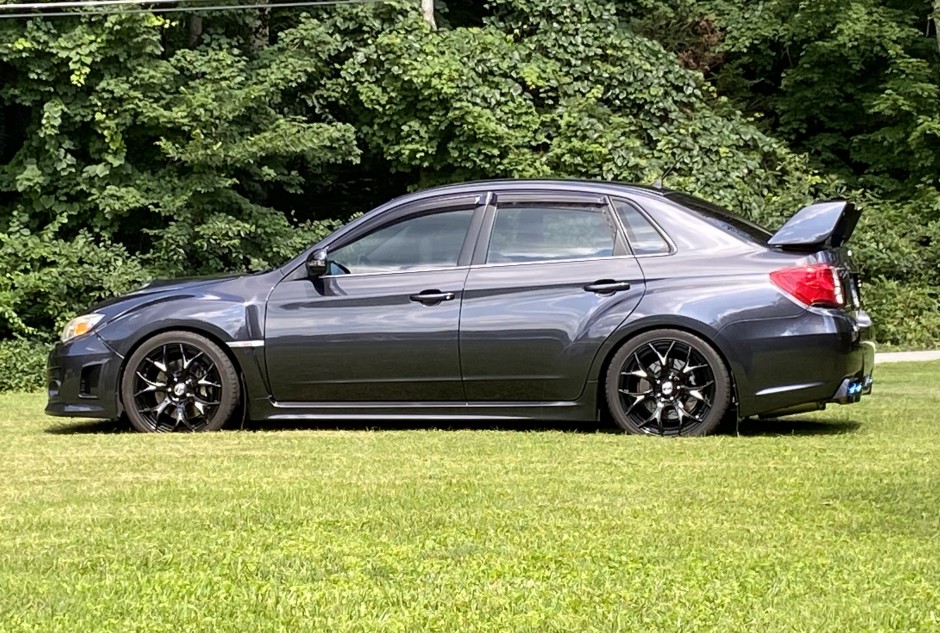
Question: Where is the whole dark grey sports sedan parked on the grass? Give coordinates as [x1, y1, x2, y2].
[46, 181, 874, 435]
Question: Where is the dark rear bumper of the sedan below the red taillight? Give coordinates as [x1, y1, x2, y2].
[720, 308, 875, 417]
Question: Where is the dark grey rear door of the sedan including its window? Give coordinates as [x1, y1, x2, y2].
[460, 192, 644, 402]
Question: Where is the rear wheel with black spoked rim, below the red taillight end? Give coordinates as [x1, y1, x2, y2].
[605, 330, 731, 436]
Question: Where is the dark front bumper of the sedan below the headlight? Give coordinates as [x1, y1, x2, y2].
[46, 333, 123, 419]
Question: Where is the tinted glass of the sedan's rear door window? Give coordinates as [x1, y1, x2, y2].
[486, 203, 616, 263]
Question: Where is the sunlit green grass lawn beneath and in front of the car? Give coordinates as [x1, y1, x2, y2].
[0, 363, 940, 631]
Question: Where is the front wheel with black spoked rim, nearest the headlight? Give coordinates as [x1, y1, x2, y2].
[121, 332, 241, 433]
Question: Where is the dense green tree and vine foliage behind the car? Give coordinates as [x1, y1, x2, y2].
[0, 0, 940, 360]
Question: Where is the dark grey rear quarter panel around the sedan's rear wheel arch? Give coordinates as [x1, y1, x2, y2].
[596, 199, 850, 415]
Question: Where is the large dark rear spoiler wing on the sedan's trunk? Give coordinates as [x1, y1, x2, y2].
[767, 200, 862, 251]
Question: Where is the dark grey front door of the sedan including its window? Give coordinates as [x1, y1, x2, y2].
[265, 196, 483, 403]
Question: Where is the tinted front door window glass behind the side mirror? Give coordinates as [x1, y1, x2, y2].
[330, 209, 473, 273]
